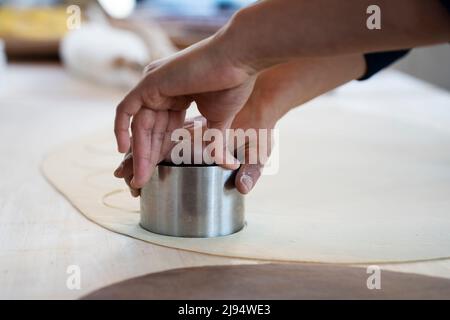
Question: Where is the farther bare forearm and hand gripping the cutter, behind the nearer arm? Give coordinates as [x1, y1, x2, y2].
[115, 55, 365, 197]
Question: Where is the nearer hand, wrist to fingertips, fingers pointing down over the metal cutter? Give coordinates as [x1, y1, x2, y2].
[115, 35, 255, 189]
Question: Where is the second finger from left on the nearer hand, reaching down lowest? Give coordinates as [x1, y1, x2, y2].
[131, 109, 155, 189]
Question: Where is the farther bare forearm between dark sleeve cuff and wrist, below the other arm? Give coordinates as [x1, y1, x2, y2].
[233, 54, 366, 128]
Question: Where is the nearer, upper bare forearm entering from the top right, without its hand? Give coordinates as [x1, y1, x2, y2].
[221, 0, 450, 71]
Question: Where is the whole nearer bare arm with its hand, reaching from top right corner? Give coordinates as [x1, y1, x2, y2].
[115, 0, 450, 189]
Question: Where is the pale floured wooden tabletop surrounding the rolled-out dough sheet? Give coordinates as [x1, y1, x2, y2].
[0, 65, 450, 299]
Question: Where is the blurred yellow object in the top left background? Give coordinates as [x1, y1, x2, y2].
[0, 7, 67, 41]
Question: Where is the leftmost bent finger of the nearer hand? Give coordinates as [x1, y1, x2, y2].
[114, 93, 142, 153]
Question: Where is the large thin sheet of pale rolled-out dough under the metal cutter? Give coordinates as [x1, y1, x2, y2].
[43, 105, 450, 263]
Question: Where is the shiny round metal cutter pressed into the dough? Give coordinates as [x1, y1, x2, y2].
[140, 163, 245, 237]
